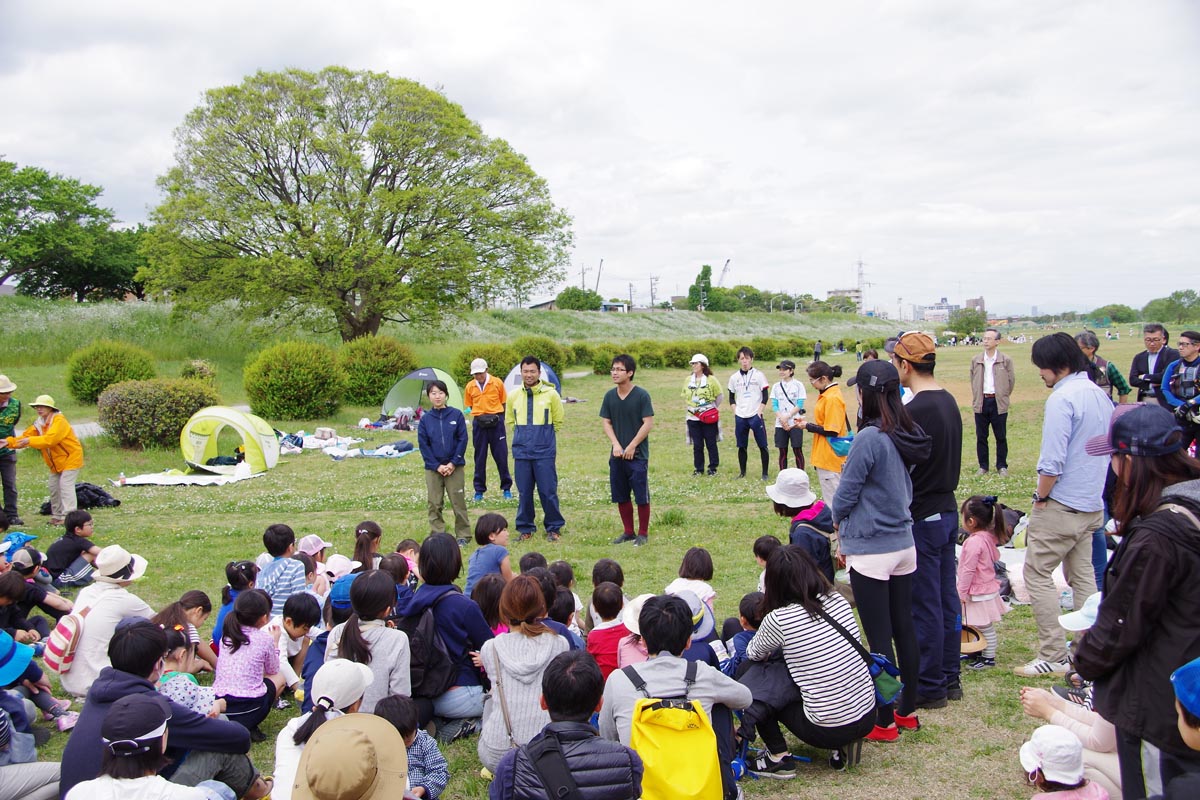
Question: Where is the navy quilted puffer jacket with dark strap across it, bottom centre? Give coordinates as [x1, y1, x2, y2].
[487, 722, 642, 800]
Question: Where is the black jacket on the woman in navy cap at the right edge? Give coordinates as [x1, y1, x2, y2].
[1075, 481, 1200, 759]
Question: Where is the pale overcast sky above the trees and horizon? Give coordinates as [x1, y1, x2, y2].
[0, 0, 1200, 317]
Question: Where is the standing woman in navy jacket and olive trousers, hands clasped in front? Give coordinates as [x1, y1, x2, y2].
[416, 380, 470, 545]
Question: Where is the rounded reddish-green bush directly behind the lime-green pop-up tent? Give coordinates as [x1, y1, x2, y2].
[97, 378, 221, 447]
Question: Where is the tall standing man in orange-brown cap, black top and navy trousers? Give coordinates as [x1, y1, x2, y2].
[892, 333, 964, 709]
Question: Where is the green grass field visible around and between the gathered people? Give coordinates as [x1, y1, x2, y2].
[2, 297, 1141, 799]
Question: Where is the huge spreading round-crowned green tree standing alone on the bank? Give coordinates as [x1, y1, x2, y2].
[143, 67, 571, 339]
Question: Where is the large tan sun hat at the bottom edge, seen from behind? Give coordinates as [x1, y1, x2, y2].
[292, 714, 408, 800]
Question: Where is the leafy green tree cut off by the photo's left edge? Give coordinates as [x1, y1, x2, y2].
[0, 160, 113, 294]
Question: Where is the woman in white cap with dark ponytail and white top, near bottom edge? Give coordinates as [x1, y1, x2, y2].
[271, 658, 374, 800]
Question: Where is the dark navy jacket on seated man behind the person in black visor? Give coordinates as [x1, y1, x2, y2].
[59, 667, 250, 798]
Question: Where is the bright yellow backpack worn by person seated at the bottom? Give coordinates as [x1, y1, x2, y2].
[622, 661, 724, 800]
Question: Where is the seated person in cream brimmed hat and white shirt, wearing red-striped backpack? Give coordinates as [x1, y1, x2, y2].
[59, 545, 154, 697]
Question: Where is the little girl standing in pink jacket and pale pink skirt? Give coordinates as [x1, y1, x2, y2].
[958, 494, 1012, 669]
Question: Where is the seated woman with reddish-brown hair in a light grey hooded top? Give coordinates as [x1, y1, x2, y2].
[478, 575, 566, 772]
